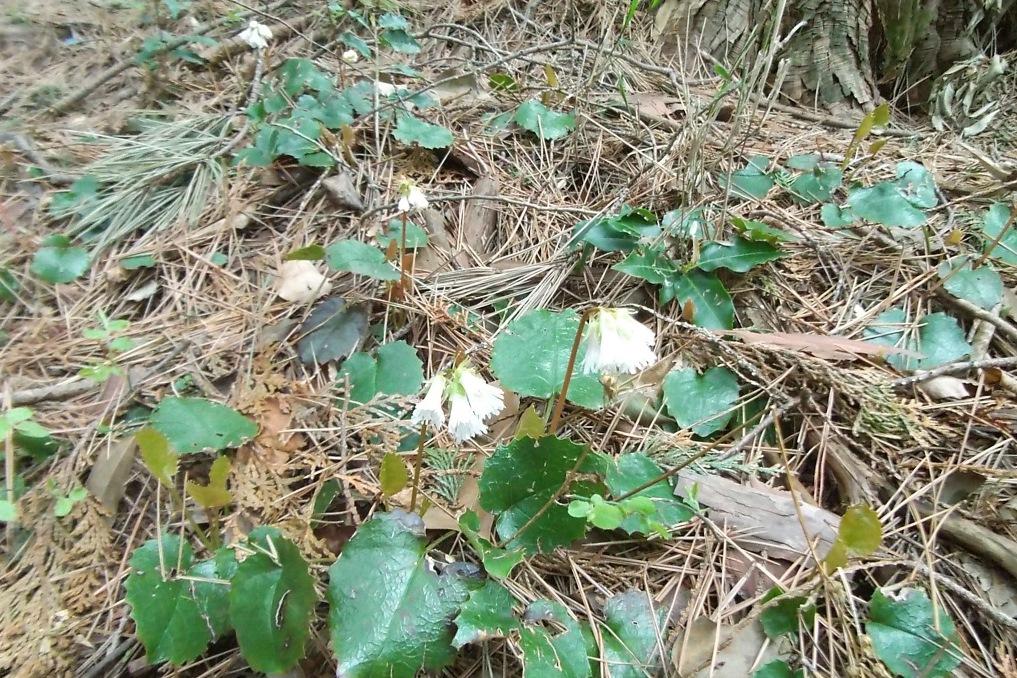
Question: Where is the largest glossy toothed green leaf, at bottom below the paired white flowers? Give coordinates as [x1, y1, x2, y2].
[328, 511, 469, 678]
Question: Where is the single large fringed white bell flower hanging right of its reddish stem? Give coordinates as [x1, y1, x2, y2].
[583, 308, 657, 374]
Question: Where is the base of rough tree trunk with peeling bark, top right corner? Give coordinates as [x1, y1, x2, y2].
[655, 0, 1017, 109]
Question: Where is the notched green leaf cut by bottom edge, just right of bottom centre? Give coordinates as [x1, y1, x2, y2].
[519, 600, 592, 678]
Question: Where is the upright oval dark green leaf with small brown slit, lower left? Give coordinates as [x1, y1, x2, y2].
[230, 528, 317, 673]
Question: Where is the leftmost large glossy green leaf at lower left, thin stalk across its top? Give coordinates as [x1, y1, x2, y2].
[125, 534, 212, 665]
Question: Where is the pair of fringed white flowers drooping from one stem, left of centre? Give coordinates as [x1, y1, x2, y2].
[411, 362, 504, 443]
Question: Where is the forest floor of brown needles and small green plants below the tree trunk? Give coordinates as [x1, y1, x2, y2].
[0, 0, 1017, 677]
